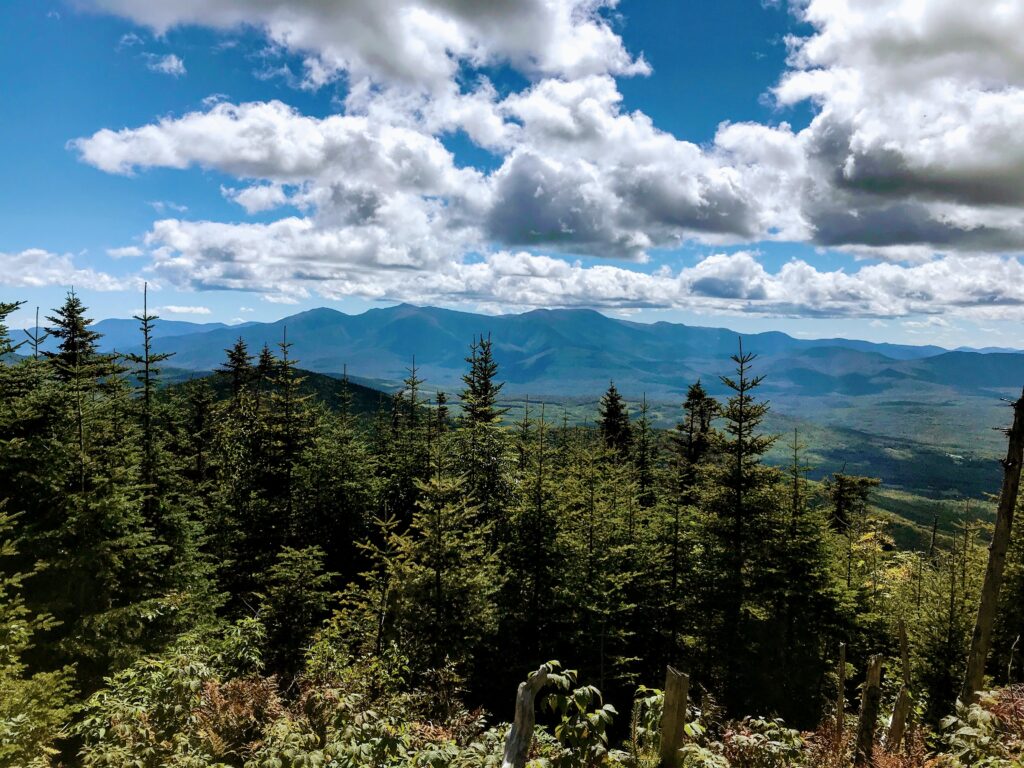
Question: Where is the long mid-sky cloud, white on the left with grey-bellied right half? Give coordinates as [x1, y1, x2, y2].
[72, 86, 771, 259]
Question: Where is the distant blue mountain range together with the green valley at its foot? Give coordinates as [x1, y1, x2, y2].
[74, 304, 1024, 499]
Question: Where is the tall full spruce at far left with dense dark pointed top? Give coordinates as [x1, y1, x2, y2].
[10, 294, 174, 690]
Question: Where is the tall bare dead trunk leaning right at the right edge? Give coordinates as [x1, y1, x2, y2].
[961, 392, 1024, 703]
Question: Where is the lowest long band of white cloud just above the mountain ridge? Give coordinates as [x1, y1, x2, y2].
[132, 211, 1024, 319]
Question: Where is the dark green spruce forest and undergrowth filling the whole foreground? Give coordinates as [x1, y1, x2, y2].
[0, 294, 1024, 768]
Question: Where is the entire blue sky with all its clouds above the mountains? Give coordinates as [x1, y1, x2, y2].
[6, 0, 1024, 347]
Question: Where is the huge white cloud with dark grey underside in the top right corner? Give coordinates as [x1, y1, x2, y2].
[774, 0, 1024, 252]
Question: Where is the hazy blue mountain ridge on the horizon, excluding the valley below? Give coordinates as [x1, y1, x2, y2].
[96, 304, 1024, 401]
